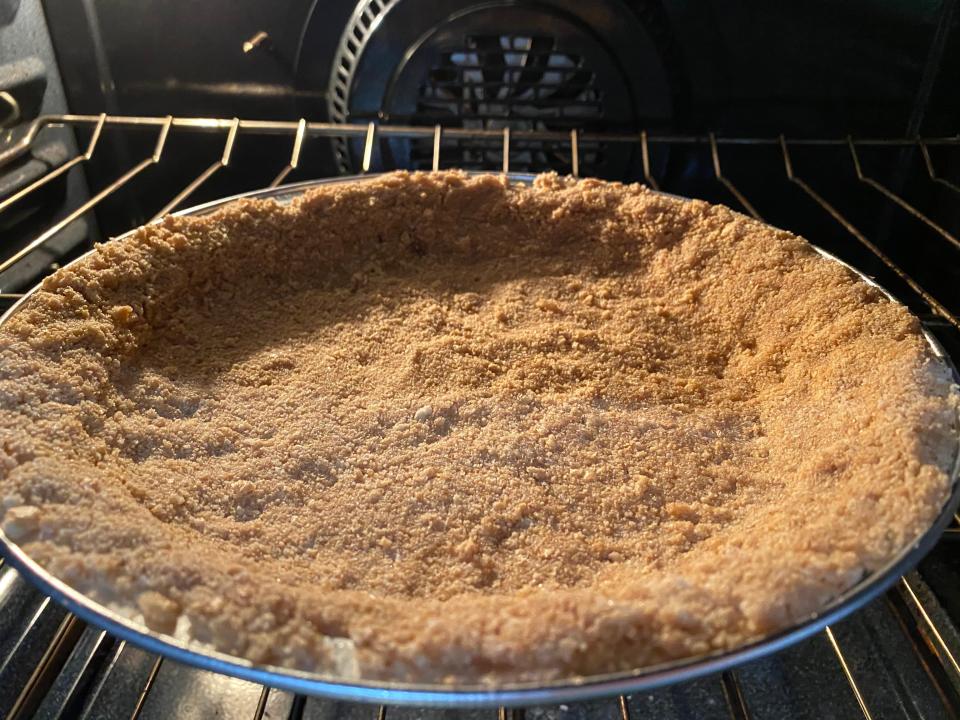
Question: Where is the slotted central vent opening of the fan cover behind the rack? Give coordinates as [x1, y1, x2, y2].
[411, 35, 604, 174]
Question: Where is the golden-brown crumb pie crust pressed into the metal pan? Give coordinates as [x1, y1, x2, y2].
[0, 172, 955, 683]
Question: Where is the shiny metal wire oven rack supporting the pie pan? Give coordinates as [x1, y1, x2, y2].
[0, 113, 960, 720]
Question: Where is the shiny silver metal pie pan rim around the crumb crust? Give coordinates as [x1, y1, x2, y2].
[0, 173, 960, 707]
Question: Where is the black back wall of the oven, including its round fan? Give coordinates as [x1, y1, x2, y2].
[44, 0, 960, 240]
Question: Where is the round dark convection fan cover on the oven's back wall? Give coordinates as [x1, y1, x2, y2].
[316, 0, 672, 178]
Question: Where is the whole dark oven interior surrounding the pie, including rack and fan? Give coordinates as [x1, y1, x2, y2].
[0, 0, 960, 720]
